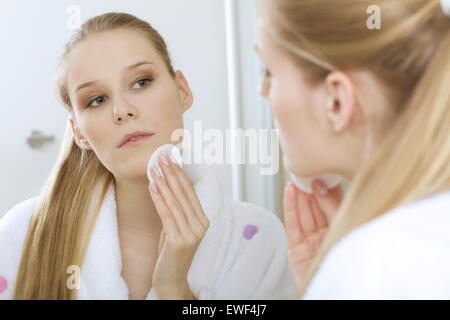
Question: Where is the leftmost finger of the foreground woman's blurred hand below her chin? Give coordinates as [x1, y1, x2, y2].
[283, 182, 305, 246]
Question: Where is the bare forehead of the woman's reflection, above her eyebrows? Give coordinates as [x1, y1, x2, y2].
[67, 29, 162, 90]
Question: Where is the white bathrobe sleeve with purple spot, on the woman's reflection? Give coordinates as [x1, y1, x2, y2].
[213, 200, 297, 300]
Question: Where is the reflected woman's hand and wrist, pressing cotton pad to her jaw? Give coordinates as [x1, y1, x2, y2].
[149, 154, 209, 300]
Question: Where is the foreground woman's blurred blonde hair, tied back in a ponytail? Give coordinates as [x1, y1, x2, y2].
[269, 0, 450, 298]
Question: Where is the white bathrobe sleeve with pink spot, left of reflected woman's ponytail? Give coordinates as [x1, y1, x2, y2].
[0, 197, 38, 300]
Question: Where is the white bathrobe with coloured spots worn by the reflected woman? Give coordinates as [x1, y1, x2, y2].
[0, 165, 296, 300]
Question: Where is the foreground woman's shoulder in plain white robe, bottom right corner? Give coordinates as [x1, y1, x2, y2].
[305, 189, 450, 299]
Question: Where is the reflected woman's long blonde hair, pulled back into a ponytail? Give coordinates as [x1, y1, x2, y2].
[13, 13, 175, 299]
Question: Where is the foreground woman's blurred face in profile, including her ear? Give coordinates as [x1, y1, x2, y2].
[256, 1, 373, 177]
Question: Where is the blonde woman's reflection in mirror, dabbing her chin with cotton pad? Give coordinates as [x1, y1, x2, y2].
[0, 13, 296, 299]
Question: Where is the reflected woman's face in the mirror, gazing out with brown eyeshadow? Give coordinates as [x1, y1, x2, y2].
[67, 29, 193, 178]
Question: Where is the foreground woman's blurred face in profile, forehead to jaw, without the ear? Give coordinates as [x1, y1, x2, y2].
[256, 13, 329, 176]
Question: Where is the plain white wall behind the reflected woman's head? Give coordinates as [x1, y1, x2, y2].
[0, 0, 232, 216]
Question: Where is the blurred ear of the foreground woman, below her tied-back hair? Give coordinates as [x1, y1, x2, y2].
[325, 71, 360, 132]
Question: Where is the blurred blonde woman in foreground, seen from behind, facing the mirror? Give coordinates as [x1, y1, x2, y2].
[256, 0, 450, 299]
